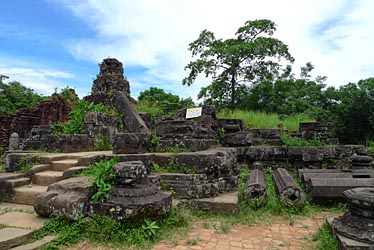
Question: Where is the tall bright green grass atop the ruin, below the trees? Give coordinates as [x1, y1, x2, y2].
[217, 110, 315, 130]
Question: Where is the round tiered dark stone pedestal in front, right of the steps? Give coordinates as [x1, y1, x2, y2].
[90, 161, 172, 221]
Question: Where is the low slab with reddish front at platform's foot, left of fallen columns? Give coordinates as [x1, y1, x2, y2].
[179, 192, 239, 214]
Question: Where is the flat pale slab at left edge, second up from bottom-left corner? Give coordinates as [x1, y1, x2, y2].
[0, 211, 44, 229]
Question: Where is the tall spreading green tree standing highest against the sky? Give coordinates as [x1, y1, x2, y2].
[182, 19, 294, 108]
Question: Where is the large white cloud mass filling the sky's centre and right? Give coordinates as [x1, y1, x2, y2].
[58, 0, 374, 98]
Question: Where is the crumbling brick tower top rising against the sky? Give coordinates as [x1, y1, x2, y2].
[84, 58, 130, 105]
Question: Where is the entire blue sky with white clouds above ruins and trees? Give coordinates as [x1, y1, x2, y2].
[0, 0, 374, 99]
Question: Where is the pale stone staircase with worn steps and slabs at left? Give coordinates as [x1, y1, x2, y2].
[0, 152, 111, 250]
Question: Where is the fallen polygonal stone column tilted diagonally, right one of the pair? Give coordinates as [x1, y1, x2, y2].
[273, 168, 305, 207]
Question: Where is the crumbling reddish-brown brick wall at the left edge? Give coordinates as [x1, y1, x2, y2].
[0, 94, 72, 147]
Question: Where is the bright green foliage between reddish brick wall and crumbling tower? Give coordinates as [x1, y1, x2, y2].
[53, 100, 114, 134]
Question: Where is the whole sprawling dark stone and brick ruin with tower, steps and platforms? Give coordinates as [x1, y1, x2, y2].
[0, 58, 374, 248]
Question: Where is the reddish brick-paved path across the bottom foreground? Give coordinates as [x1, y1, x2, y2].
[153, 212, 337, 250]
